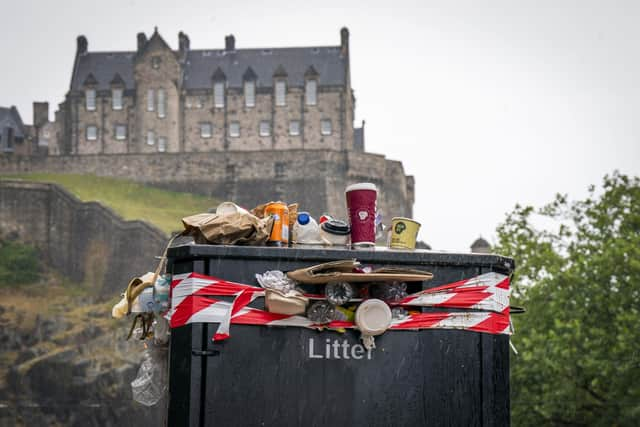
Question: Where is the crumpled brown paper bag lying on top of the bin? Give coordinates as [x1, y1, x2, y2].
[182, 212, 273, 245]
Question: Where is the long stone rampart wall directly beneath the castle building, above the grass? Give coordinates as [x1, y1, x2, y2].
[0, 150, 414, 219]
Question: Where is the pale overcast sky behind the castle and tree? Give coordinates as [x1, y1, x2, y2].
[0, 0, 640, 251]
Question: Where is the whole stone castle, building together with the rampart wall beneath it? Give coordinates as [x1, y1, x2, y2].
[0, 28, 414, 218]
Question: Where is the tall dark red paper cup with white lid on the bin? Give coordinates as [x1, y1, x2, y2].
[345, 182, 378, 247]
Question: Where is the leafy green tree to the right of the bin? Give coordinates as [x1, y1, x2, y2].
[496, 172, 640, 426]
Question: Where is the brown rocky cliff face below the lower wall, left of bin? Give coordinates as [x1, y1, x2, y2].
[0, 273, 166, 427]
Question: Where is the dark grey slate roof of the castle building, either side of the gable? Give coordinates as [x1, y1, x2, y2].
[71, 46, 346, 90]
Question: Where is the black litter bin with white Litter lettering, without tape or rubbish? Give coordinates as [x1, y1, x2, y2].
[168, 245, 514, 427]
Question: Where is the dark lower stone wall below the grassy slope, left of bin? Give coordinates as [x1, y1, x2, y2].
[0, 180, 167, 297]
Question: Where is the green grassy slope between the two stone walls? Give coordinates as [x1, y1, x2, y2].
[4, 174, 219, 233]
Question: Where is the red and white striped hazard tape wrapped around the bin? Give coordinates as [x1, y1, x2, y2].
[165, 273, 511, 340]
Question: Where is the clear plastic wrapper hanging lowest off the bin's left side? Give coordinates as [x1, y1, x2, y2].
[131, 346, 167, 406]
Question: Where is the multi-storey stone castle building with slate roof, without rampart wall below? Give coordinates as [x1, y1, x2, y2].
[50, 28, 364, 155]
